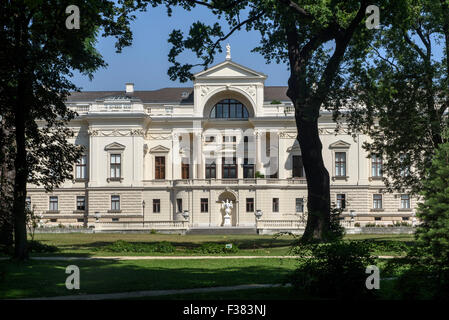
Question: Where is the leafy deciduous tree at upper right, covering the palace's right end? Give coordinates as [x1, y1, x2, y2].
[337, 0, 449, 194]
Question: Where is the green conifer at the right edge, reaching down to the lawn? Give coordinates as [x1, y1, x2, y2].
[398, 129, 449, 300]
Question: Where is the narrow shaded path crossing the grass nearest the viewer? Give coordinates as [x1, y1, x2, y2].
[20, 284, 291, 300]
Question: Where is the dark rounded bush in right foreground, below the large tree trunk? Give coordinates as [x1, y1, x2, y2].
[290, 241, 375, 299]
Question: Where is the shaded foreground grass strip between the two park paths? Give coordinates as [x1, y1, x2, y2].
[0, 258, 296, 299]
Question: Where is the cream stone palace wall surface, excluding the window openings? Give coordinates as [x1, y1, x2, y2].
[28, 62, 416, 227]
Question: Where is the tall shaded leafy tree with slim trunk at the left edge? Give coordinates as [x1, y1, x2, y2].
[0, 0, 133, 260]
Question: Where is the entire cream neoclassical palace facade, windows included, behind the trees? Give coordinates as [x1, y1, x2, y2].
[27, 55, 416, 230]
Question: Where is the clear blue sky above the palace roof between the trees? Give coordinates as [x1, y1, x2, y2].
[72, 7, 289, 91]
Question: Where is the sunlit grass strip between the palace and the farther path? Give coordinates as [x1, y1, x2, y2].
[23, 233, 413, 256]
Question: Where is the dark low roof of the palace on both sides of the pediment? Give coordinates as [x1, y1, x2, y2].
[67, 86, 290, 104]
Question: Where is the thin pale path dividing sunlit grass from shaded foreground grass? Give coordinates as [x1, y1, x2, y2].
[0, 256, 400, 261]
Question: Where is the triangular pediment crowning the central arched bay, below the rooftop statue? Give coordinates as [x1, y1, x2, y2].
[194, 60, 267, 79]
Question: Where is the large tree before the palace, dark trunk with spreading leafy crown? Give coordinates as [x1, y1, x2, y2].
[130, 0, 372, 241]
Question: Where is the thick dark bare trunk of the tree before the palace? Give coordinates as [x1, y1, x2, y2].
[296, 110, 330, 242]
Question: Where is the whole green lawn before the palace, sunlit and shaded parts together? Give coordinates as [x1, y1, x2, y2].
[0, 233, 413, 299]
